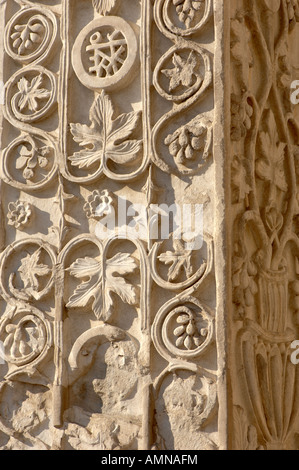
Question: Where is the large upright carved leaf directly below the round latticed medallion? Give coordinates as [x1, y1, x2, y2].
[69, 92, 142, 168]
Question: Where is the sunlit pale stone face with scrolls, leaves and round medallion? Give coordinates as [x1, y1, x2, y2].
[0, 0, 223, 450]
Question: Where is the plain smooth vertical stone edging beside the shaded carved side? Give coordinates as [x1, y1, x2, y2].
[214, 0, 231, 450]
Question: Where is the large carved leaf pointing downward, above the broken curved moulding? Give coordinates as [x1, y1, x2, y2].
[67, 253, 137, 321]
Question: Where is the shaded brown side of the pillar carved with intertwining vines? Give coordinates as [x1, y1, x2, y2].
[230, 0, 299, 450]
